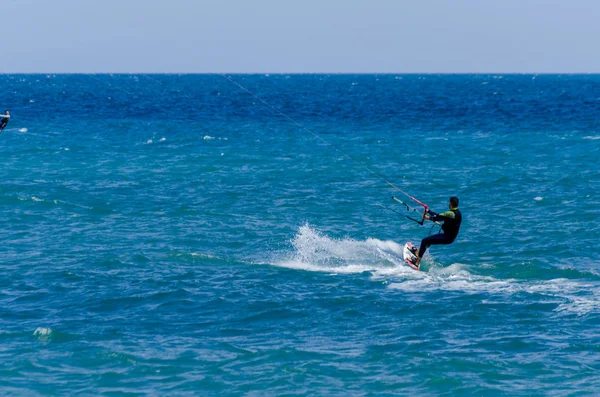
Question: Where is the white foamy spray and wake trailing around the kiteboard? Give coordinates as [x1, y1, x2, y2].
[274, 225, 600, 315]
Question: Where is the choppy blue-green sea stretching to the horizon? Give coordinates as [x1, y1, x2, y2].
[0, 75, 600, 396]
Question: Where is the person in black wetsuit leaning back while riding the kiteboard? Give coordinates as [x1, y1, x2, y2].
[412, 196, 462, 268]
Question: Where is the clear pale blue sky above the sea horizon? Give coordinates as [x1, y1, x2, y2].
[0, 0, 600, 73]
